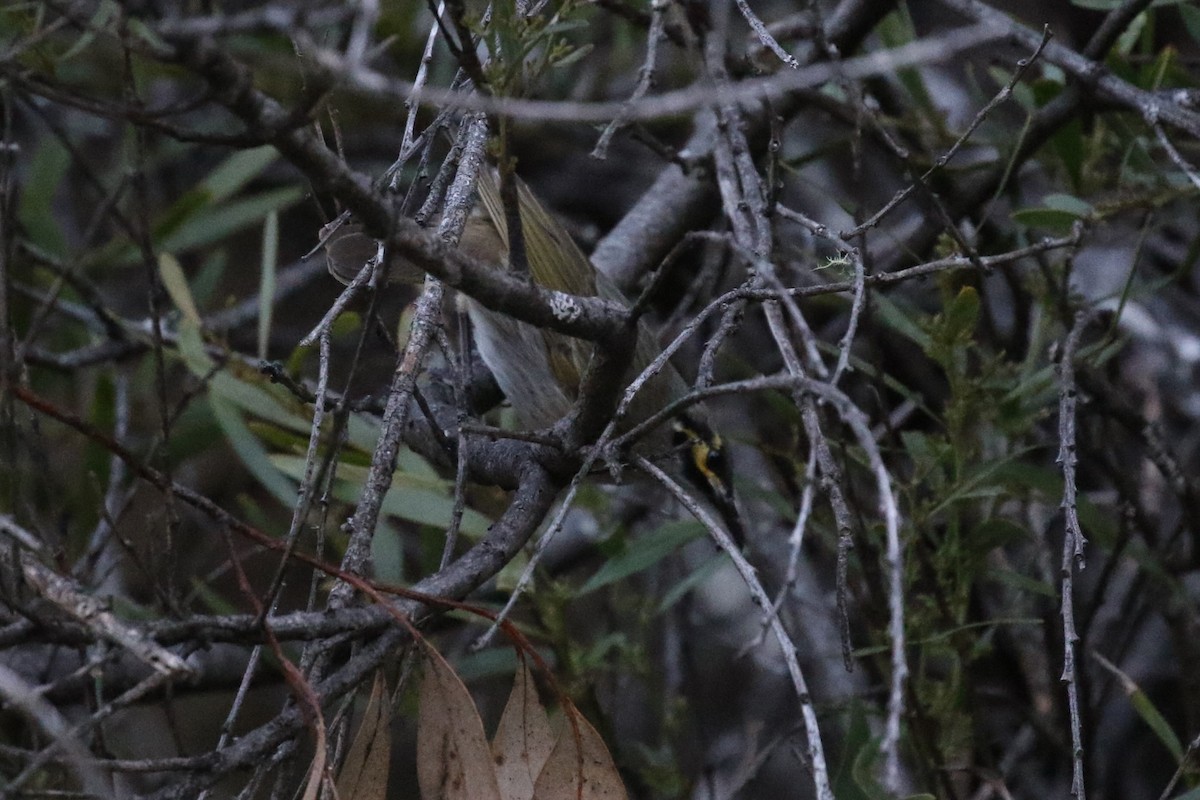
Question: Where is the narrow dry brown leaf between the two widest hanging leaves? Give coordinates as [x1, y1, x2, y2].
[492, 661, 554, 800]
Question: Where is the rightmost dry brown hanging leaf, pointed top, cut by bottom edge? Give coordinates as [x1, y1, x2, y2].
[533, 705, 628, 800]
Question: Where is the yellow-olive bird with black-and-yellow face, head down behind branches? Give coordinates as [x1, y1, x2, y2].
[323, 166, 745, 547]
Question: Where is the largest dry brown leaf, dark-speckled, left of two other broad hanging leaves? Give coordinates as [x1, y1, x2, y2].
[416, 648, 500, 800]
